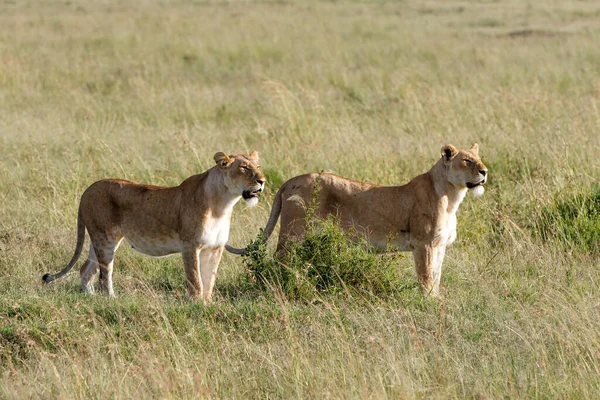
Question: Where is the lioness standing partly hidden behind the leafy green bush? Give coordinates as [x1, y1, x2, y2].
[226, 144, 488, 296]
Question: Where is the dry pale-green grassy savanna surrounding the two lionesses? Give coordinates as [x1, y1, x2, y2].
[0, 0, 600, 399]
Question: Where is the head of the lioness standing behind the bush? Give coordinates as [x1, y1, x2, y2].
[442, 143, 488, 196]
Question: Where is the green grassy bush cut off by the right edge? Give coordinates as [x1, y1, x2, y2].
[537, 188, 600, 253]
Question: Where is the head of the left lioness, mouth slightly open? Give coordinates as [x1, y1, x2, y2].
[214, 151, 266, 206]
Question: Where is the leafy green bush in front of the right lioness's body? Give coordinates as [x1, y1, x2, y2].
[244, 217, 416, 301]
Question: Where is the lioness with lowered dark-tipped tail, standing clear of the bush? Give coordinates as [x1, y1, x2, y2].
[42, 151, 265, 304]
